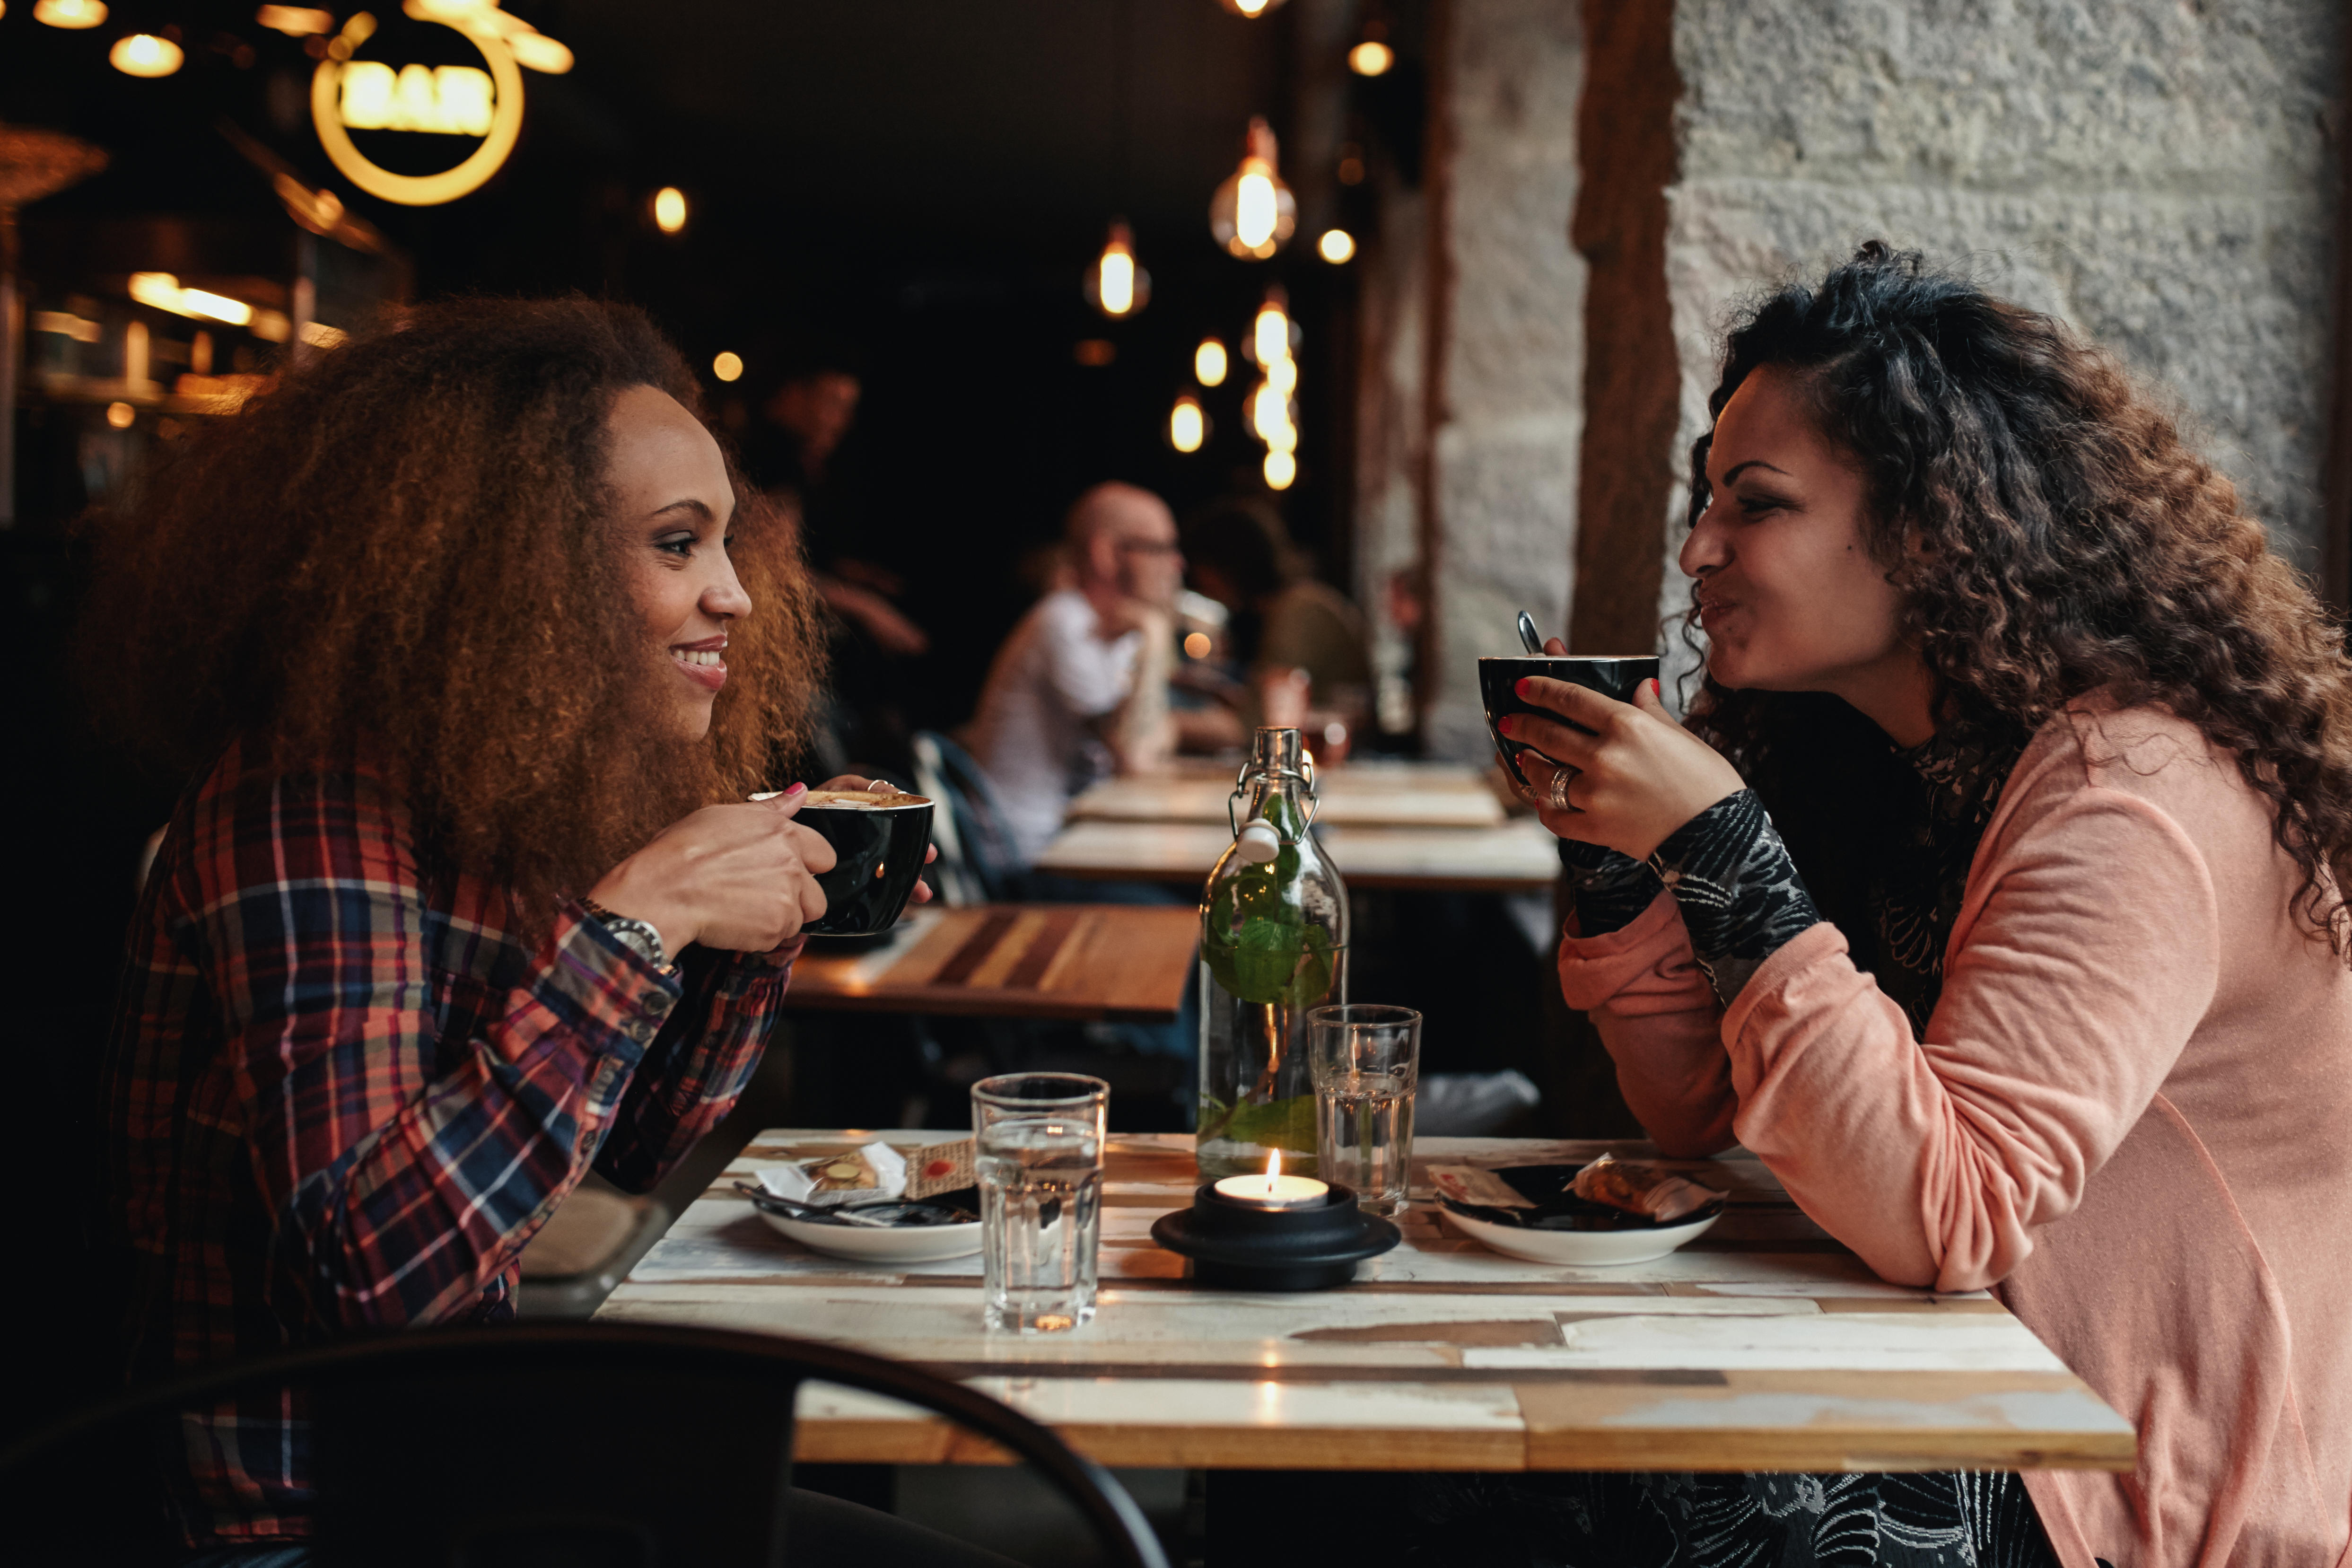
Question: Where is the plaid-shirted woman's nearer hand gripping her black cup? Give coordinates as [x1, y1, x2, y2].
[588, 785, 832, 959]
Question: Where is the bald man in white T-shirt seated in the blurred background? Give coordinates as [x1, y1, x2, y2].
[971, 484, 1183, 863]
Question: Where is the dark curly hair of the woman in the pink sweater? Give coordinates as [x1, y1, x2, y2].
[1682, 242, 2352, 952]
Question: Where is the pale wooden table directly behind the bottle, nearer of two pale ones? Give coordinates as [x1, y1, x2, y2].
[1037, 818, 1559, 893]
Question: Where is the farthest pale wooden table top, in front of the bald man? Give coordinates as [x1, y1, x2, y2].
[1070, 762, 1503, 839]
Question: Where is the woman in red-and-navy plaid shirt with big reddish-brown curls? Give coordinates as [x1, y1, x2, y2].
[89, 301, 969, 1568]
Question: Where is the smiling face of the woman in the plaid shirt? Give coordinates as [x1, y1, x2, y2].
[604, 385, 750, 741]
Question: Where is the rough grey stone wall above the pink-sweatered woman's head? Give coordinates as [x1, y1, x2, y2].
[1661, 0, 2347, 667]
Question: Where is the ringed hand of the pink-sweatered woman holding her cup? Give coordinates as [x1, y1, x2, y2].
[1498, 637, 1748, 860]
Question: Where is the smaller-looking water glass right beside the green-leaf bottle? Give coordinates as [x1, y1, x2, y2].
[1308, 1001, 1421, 1213]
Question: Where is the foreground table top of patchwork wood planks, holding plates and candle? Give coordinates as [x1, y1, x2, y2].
[597, 1131, 2133, 1469]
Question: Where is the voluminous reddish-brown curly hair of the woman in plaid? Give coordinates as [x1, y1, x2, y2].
[82, 298, 823, 924]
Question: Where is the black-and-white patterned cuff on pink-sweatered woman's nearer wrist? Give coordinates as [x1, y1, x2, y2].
[1649, 790, 1820, 1006]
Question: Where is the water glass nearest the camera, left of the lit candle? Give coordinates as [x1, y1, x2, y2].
[971, 1072, 1110, 1333]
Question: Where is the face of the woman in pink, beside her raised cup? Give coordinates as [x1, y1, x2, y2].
[1682, 367, 1931, 743]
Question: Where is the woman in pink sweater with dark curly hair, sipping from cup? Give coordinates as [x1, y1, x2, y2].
[1508, 245, 2352, 1568]
